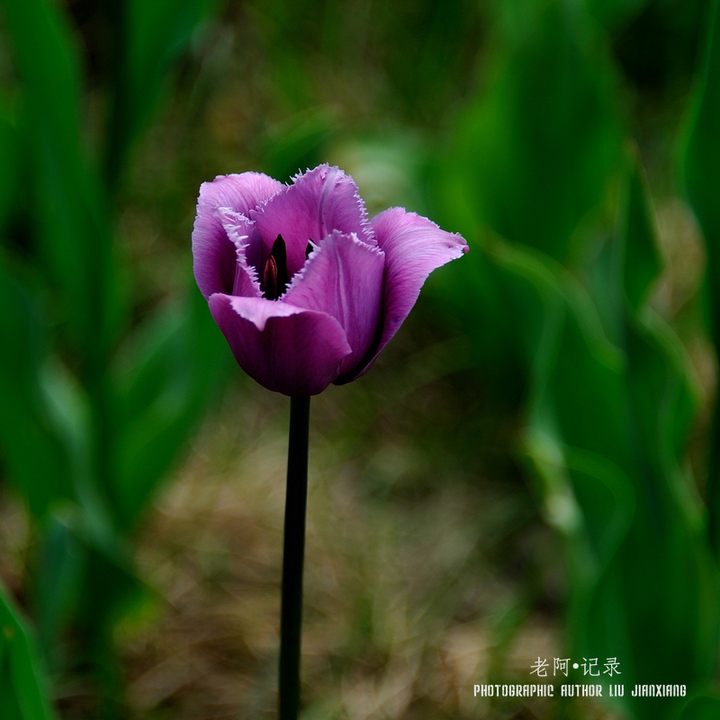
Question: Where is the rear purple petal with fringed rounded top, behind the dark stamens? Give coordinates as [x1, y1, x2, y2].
[250, 165, 375, 277]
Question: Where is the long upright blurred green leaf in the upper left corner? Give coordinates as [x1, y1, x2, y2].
[3, 0, 116, 358]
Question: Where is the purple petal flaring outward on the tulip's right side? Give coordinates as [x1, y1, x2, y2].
[341, 208, 468, 382]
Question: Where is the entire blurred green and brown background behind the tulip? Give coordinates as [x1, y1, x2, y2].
[0, 0, 720, 720]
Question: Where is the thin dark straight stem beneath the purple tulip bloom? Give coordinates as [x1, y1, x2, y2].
[280, 397, 310, 720]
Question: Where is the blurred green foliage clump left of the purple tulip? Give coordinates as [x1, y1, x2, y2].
[0, 0, 227, 718]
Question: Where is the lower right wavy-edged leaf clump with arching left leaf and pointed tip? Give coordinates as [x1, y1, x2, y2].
[484, 153, 718, 718]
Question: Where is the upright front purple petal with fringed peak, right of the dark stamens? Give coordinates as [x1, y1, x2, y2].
[284, 231, 385, 375]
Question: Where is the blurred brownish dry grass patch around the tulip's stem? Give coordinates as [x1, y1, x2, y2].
[120, 371, 609, 718]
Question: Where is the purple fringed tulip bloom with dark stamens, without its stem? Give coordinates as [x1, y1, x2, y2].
[192, 165, 467, 396]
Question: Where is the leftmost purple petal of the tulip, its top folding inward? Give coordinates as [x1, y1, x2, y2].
[192, 172, 284, 298]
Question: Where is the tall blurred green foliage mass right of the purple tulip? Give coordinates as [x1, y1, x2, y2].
[434, 3, 718, 718]
